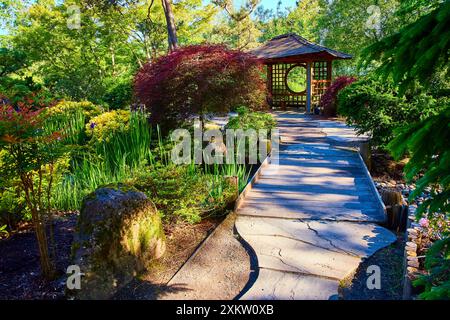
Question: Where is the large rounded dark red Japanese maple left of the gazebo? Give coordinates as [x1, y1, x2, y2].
[134, 45, 266, 130]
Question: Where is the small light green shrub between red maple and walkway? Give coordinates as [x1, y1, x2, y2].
[226, 107, 277, 131]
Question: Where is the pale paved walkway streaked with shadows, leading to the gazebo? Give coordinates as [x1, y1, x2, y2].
[235, 112, 395, 299]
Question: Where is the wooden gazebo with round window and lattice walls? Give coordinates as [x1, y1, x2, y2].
[252, 33, 352, 113]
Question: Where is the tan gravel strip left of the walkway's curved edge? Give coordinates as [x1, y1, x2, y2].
[157, 213, 252, 300]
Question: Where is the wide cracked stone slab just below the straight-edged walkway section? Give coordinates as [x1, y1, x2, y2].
[236, 216, 396, 258]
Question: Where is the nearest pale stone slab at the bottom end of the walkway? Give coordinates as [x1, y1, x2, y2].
[241, 269, 339, 300]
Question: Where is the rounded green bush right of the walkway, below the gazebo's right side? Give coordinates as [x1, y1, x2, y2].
[338, 78, 438, 147]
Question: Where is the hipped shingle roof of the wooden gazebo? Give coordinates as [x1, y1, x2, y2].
[251, 33, 352, 60]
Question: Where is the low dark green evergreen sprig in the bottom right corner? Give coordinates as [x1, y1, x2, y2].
[414, 236, 450, 300]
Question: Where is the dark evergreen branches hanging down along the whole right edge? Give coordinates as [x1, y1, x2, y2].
[363, 0, 450, 300]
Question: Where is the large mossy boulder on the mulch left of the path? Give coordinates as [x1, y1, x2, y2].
[70, 184, 165, 299]
